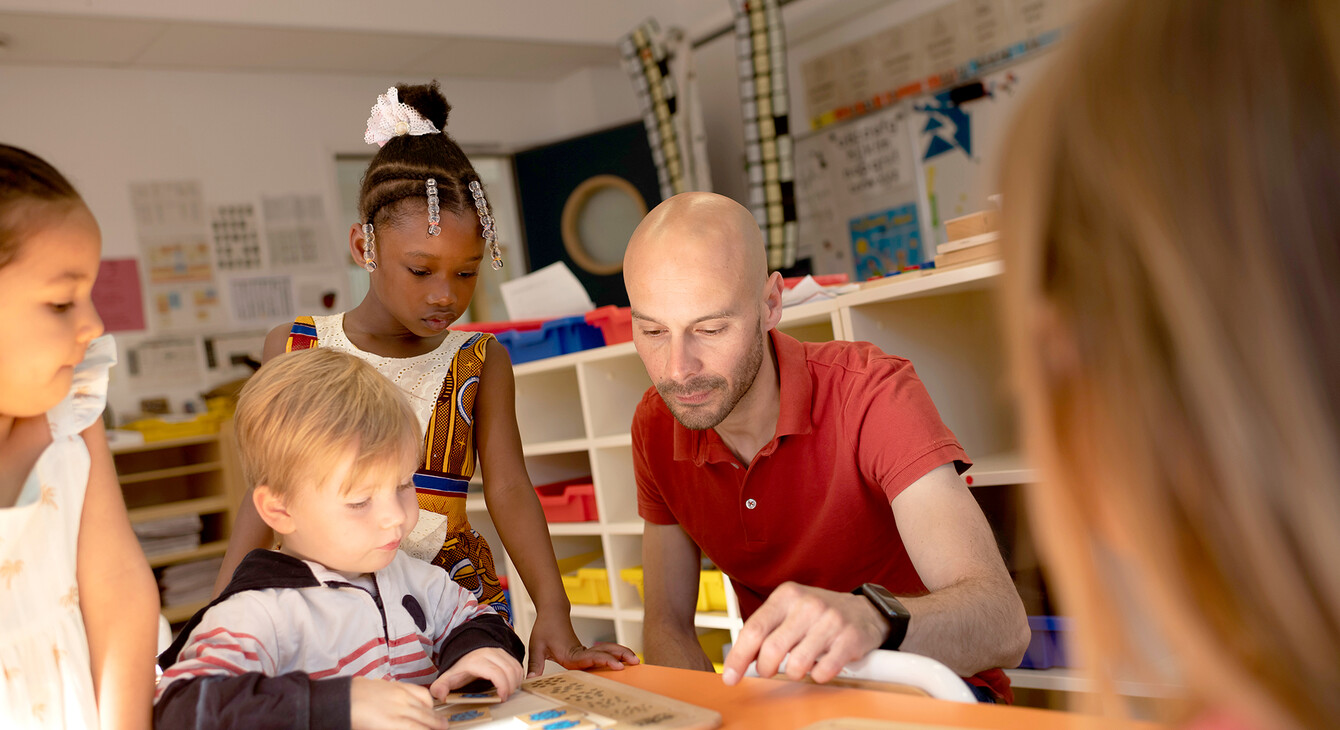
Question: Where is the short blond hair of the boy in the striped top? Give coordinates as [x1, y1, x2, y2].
[237, 347, 422, 498]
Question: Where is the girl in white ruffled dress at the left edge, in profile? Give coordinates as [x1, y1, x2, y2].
[0, 145, 158, 729]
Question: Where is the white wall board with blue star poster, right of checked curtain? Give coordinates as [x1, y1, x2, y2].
[796, 54, 1052, 280]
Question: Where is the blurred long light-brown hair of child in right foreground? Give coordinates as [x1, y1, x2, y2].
[1002, 0, 1340, 727]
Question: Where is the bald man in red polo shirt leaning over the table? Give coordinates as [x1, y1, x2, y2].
[623, 193, 1029, 701]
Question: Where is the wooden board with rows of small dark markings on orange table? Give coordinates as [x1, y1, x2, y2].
[521, 671, 721, 730]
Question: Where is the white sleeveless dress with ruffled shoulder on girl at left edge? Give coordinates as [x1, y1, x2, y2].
[0, 335, 117, 730]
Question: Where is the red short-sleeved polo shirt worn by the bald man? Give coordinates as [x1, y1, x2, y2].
[632, 330, 1012, 698]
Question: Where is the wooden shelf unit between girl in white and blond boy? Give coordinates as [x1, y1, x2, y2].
[111, 422, 243, 623]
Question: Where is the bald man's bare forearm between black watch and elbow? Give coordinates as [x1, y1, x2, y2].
[899, 579, 1029, 676]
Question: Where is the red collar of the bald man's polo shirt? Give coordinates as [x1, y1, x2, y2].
[671, 330, 815, 466]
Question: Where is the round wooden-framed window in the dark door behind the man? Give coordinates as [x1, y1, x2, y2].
[563, 175, 647, 276]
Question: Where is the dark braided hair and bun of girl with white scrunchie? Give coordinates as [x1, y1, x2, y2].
[358, 80, 482, 225]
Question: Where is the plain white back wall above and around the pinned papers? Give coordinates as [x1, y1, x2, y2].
[0, 66, 638, 415]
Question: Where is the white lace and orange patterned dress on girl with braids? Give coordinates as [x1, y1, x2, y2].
[285, 313, 512, 622]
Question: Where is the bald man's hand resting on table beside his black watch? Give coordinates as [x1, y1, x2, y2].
[722, 583, 888, 684]
